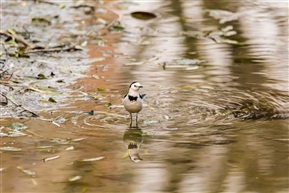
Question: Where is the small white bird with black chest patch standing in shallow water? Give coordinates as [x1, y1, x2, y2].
[122, 82, 146, 127]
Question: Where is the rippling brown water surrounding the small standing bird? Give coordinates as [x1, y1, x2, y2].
[0, 0, 289, 193]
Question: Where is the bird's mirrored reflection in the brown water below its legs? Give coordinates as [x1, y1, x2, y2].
[123, 127, 143, 162]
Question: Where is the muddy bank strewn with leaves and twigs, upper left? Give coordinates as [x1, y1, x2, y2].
[1, 1, 118, 118]
